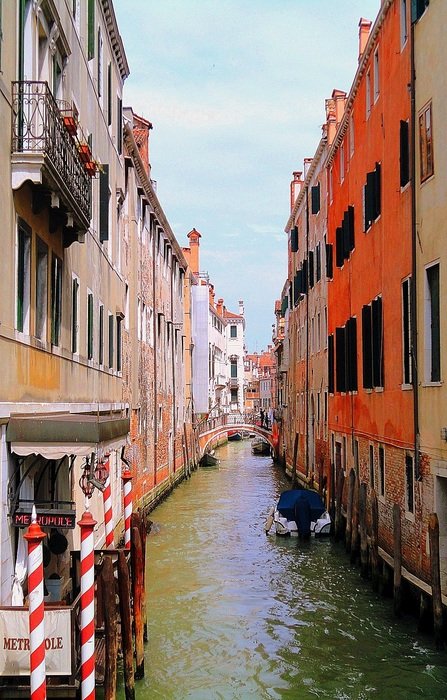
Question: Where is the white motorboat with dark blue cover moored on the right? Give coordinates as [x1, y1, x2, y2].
[264, 489, 331, 538]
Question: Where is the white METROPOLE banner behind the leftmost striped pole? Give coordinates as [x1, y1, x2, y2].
[0, 608, 72, 676]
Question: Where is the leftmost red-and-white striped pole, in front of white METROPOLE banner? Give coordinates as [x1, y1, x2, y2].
[24, 506, 47, 700]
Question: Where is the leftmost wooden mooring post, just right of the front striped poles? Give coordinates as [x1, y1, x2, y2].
[101, 555, 118, 700]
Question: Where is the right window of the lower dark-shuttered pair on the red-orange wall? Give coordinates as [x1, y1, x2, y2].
[362, 297, 383, 389]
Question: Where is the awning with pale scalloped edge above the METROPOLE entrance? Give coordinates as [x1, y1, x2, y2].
[6, 413, 130, 459]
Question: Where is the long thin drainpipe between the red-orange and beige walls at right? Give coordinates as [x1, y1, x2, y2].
[410, 22, 422, 481]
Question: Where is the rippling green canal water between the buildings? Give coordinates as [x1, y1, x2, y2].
[118, 441, 447, 700]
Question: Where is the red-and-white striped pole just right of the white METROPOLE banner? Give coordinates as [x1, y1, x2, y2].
[78, 502, 96, 700]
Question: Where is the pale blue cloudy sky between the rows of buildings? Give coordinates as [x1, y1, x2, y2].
[114, 0, 380, 352]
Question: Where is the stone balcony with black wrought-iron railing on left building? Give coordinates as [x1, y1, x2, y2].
[11, 81, 91, 246]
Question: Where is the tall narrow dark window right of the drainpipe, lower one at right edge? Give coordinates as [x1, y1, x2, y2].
[425, 264, 441, 382]
